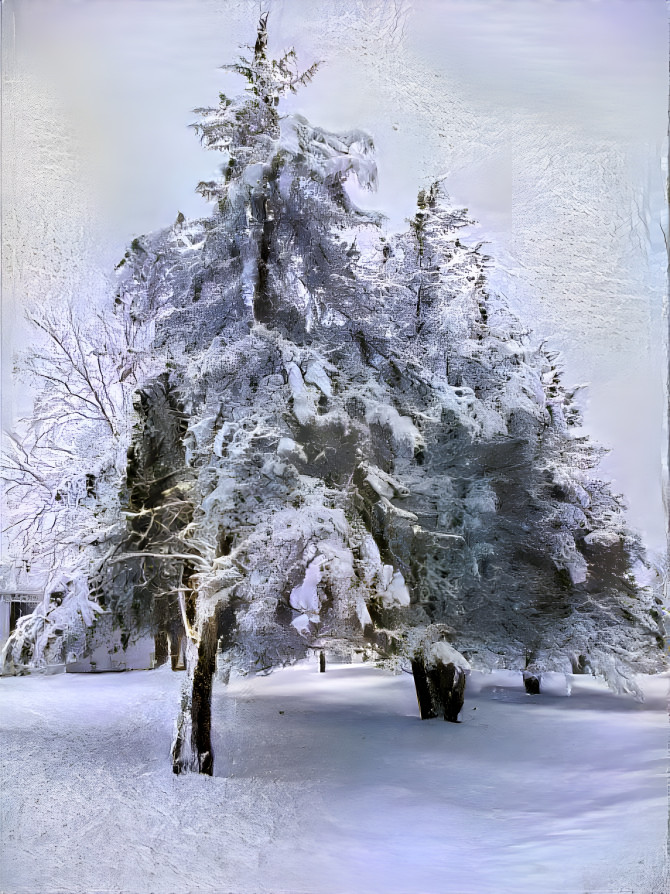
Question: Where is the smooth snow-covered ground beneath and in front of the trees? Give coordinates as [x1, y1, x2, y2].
[0, 663, 669, 894]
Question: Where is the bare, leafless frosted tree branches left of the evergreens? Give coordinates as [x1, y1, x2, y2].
[0, 270, 157, 673]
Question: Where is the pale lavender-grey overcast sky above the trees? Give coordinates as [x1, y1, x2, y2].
[2, 0, 668, 549]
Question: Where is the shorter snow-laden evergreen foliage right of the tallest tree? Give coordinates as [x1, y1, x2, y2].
[356, 184, 664, 708]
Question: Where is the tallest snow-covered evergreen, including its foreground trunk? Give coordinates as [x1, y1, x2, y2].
[110, 17, 388, 772]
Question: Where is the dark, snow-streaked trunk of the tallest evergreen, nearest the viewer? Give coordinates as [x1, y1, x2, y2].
[172, 615, 218, 776]
